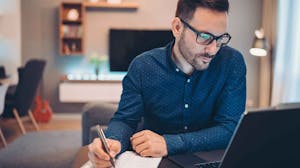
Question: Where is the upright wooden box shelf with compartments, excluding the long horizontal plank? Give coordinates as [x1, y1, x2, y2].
[59, 2, 85, 55]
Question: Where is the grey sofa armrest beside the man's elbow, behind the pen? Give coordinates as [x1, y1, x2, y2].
[81, 102, 117, 146]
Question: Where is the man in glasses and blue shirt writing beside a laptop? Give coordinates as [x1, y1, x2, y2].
[89, 0, 246, 167]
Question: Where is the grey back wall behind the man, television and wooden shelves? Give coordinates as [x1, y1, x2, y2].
[21, 0, 261, 112]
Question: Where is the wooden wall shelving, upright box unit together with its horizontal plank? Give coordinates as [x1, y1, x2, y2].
[59, 0, 138, 56]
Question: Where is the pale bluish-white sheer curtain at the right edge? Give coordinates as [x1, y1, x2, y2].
[271, 0, 300, 105]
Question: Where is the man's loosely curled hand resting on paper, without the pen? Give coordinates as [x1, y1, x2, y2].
[130, 130, 168, 157]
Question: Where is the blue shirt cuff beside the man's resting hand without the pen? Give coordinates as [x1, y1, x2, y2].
[163, 135, 185, 155]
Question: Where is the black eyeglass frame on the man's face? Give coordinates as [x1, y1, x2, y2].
[179, 18, 231, 48]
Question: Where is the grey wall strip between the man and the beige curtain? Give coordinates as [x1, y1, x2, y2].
[228, 0, 262, 107]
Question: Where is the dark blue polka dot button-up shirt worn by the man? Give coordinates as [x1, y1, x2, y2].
[106, 42, 246, 155]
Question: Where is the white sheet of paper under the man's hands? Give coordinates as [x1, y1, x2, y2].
[81, 151, 161, 168]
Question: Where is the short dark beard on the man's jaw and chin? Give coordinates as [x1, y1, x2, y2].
[178, 34, 215, 71]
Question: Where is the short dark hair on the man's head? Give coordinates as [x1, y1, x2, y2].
[175, 0, 229, 21]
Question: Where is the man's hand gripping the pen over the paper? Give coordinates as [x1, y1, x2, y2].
[88, 138, 121, 168]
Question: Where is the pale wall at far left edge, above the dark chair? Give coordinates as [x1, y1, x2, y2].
[0, 0, 21, 82]
